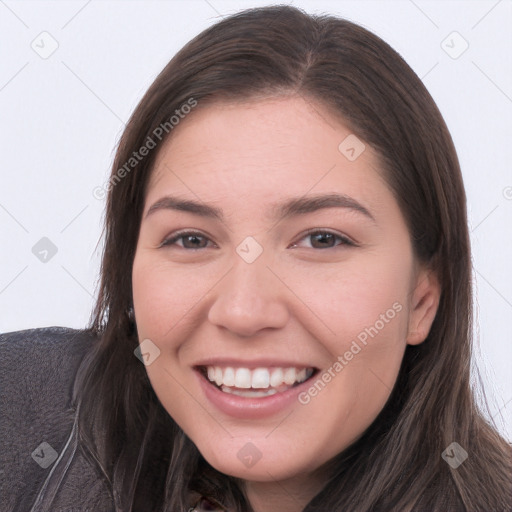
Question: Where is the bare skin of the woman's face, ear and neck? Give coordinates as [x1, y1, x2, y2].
[132, 96, 440, 512]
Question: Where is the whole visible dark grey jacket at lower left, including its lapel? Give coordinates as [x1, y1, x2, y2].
[0, 327, 114, 512]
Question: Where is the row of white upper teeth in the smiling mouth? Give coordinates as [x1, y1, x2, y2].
[206, 366, 313, 389]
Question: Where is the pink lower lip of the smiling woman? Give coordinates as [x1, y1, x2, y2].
[195, 370, 311, 419]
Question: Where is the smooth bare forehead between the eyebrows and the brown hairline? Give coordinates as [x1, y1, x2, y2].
[147, 96, 386, 214]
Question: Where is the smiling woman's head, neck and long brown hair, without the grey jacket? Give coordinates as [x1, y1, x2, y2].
[2, 6, 512, 512]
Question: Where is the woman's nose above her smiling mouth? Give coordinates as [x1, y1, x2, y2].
[208, 259, 289, 337]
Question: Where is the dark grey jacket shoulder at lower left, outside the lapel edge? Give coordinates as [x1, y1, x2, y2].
[0, 327, 111, 510]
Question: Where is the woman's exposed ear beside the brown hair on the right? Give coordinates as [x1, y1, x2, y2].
[406, 268, 441, 345]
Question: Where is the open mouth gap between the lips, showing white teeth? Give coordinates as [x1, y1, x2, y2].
[196, 366, 318, 398]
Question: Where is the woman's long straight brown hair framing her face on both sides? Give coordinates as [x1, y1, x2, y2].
[74, 6, 512, 512]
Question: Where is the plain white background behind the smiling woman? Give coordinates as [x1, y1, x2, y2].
[0, 0, 512, 439]
